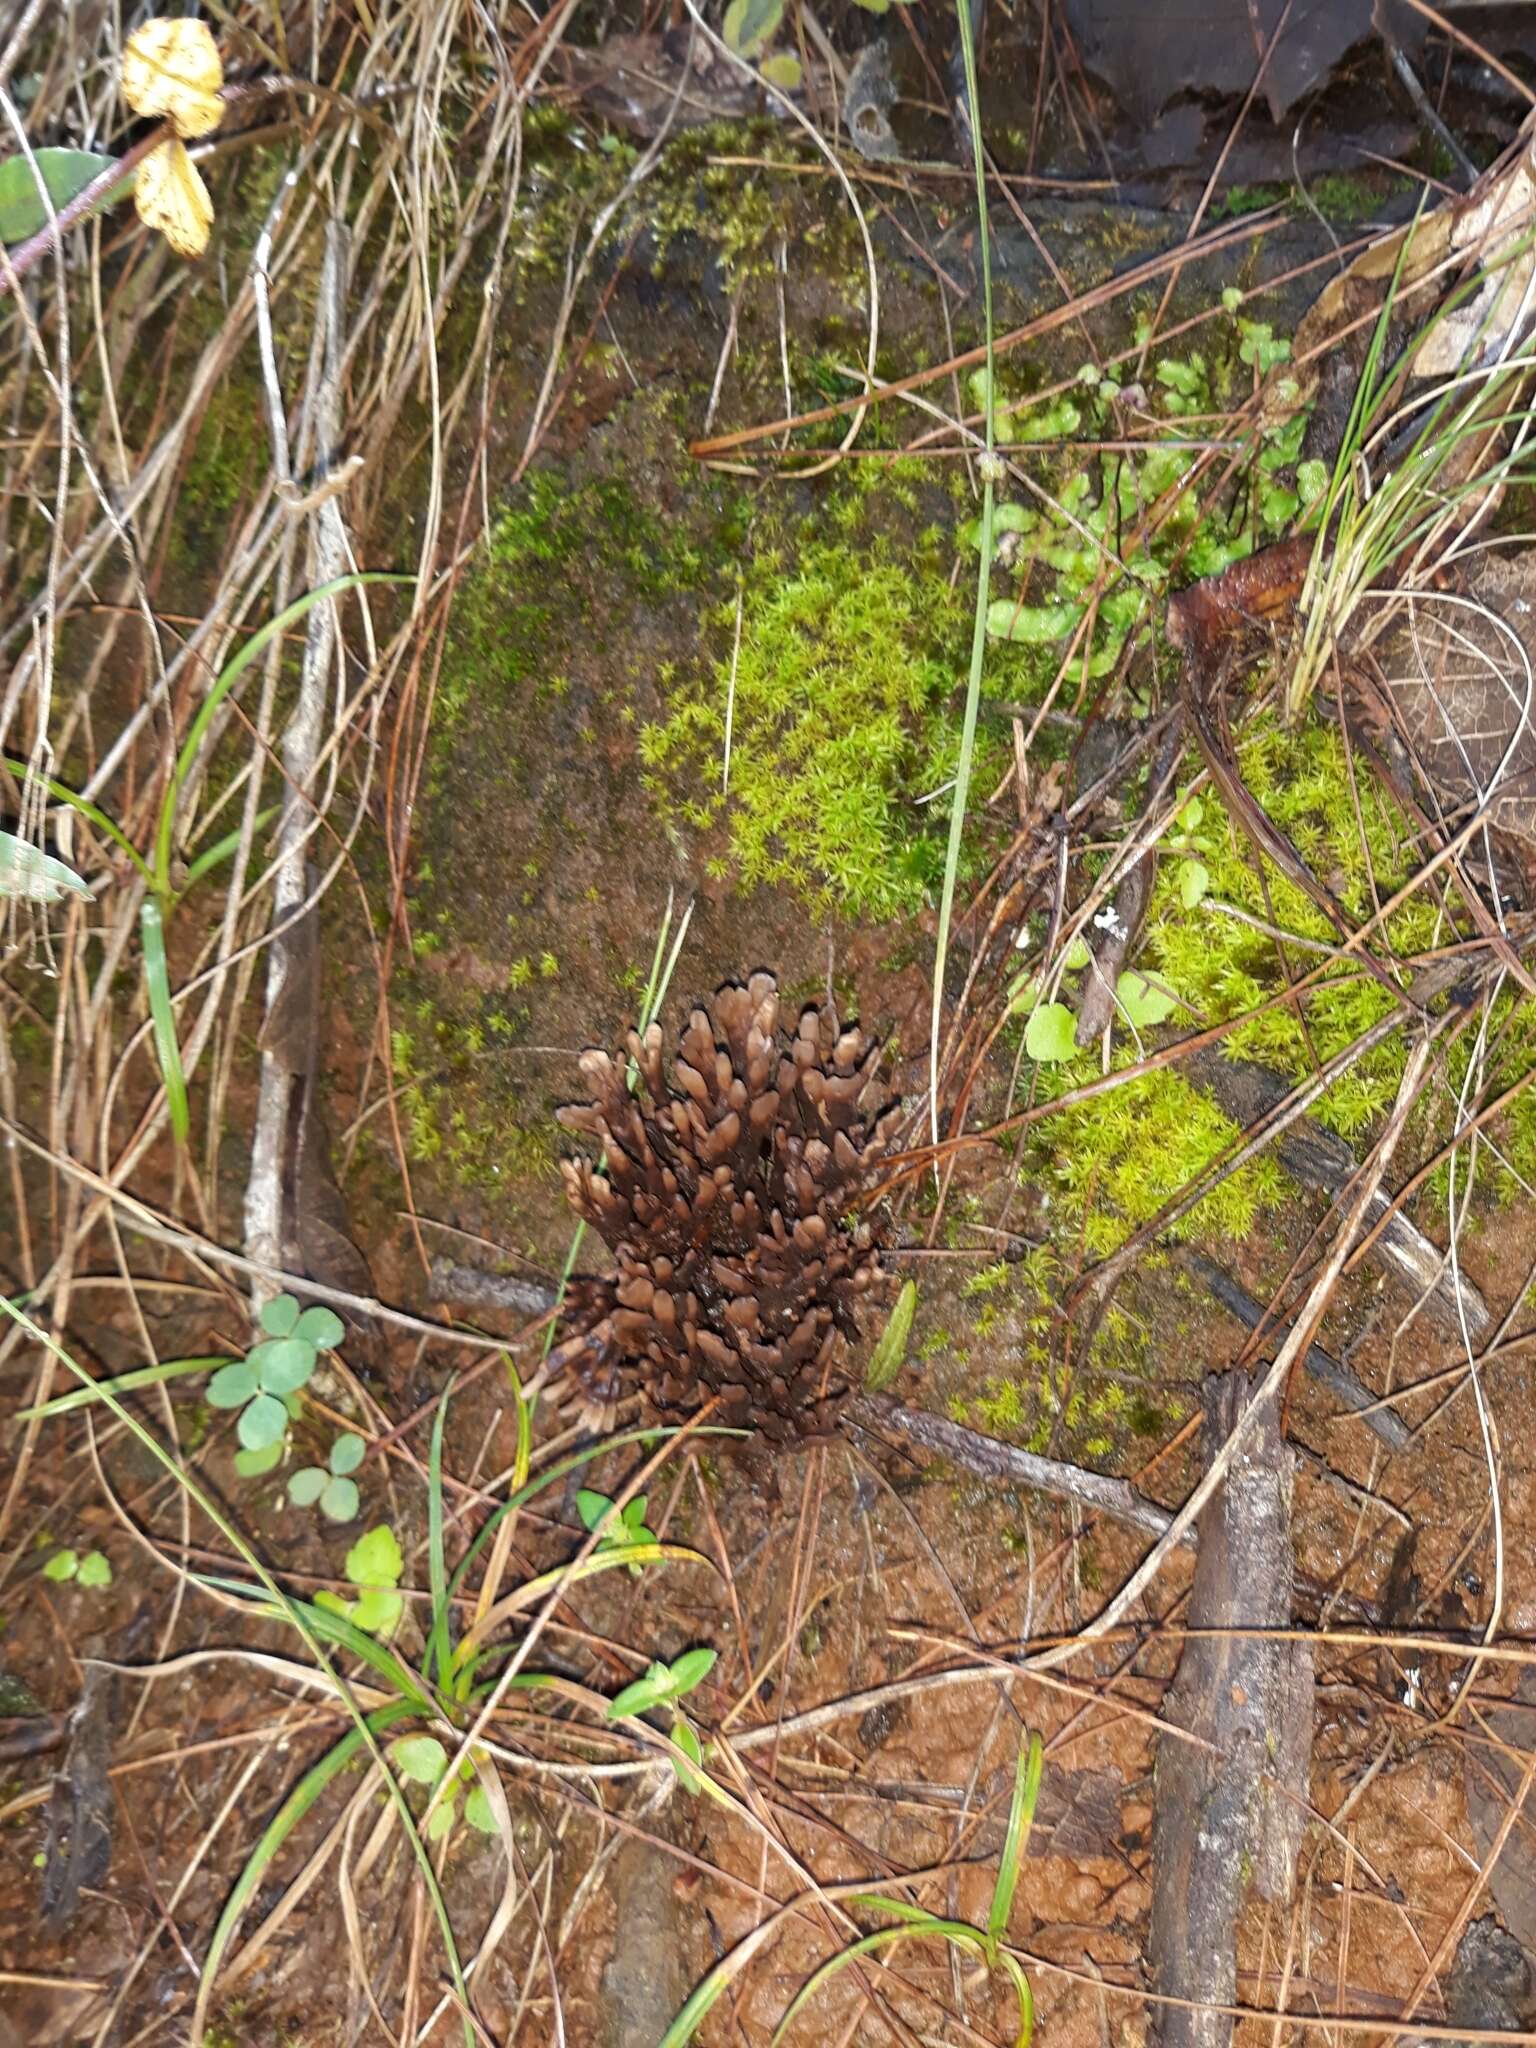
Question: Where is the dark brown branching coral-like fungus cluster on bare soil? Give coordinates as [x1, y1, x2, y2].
[551, 973, 899, 1442]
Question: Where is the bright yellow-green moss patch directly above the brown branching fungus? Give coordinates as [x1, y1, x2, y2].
[641, 473, 1040, 920]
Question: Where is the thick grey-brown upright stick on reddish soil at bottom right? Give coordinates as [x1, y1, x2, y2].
[1147, 1372, 1313, 2048]
